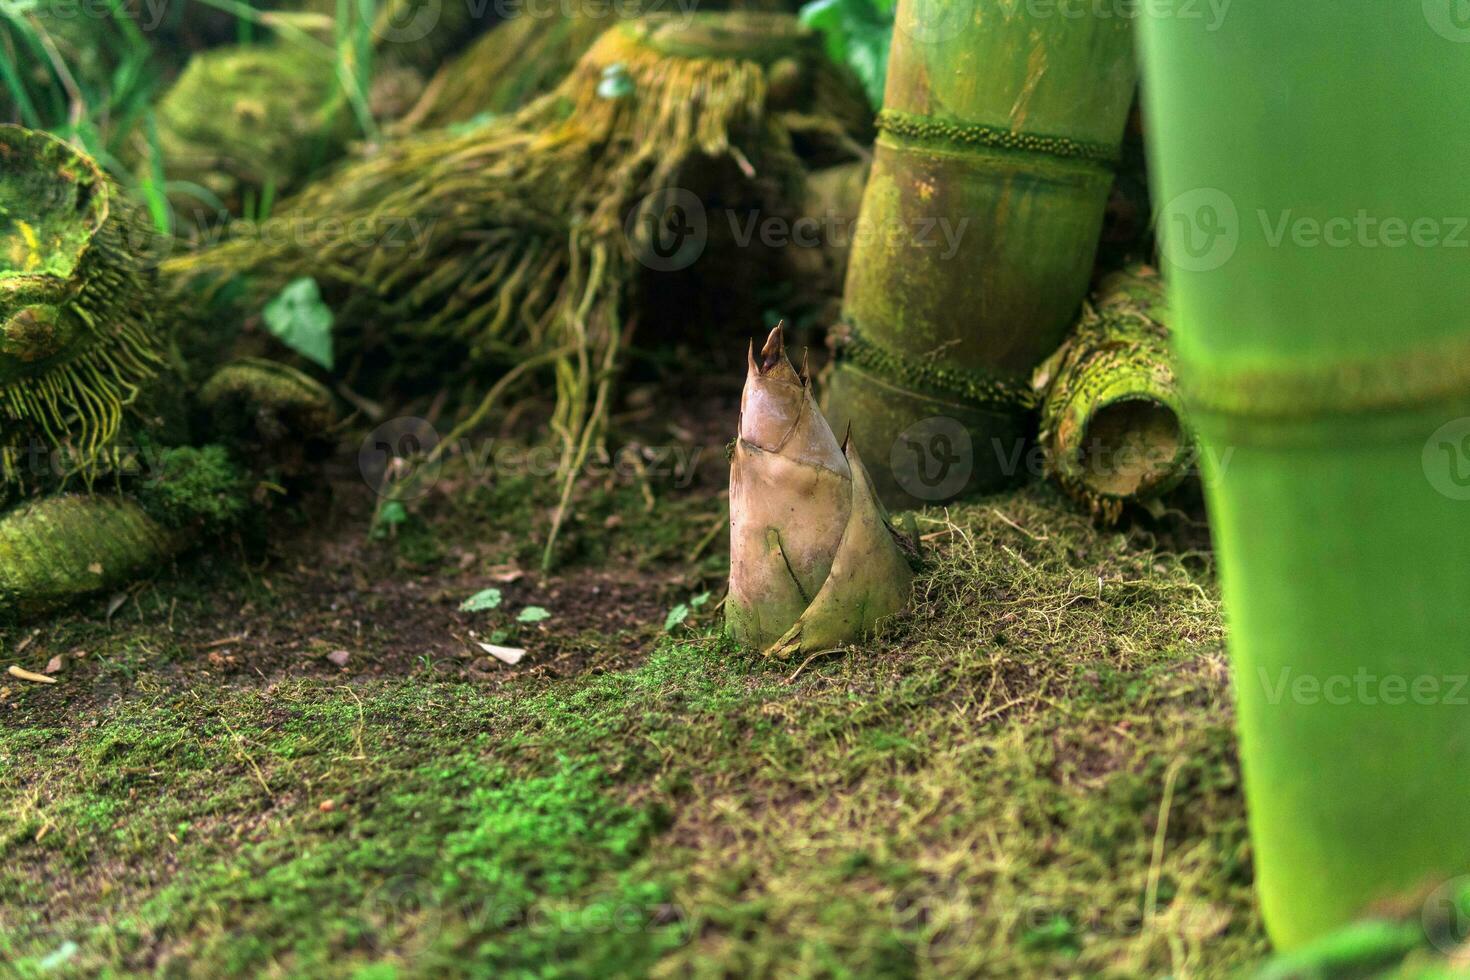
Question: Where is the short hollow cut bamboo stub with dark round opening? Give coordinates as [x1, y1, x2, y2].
[1032, 266, 1194, 525]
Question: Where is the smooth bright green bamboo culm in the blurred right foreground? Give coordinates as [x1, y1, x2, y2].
[1142, 0, 1470, 952]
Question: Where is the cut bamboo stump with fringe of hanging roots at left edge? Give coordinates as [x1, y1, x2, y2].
[0, 126, 166, 505]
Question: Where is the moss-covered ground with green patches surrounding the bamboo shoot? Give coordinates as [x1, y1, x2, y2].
[0, 446, 1264, 979]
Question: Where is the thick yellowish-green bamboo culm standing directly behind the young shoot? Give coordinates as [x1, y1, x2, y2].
[828, 0, 1135, 505]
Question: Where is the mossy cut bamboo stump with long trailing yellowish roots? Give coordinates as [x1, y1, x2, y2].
[169, 15, 867, 470]
